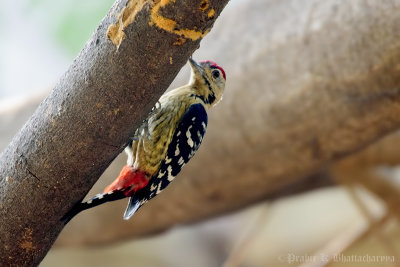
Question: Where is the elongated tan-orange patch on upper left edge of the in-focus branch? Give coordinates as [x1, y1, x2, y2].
[107, 0, 146, 47]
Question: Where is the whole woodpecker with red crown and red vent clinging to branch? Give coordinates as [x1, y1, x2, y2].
[62, 58, 226, 223]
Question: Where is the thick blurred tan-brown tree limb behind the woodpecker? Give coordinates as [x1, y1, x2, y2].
[52, 0, 400, 245]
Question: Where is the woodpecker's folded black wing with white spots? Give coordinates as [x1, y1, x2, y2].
[124, 104, 207, 219]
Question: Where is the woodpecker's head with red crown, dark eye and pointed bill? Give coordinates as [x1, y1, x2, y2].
[189, 58, 226, 109]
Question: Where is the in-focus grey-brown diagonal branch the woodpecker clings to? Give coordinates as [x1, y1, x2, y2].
[0, 0, 228, 266]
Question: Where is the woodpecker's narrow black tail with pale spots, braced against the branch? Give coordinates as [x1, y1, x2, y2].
[61, 190, 126, 224]
